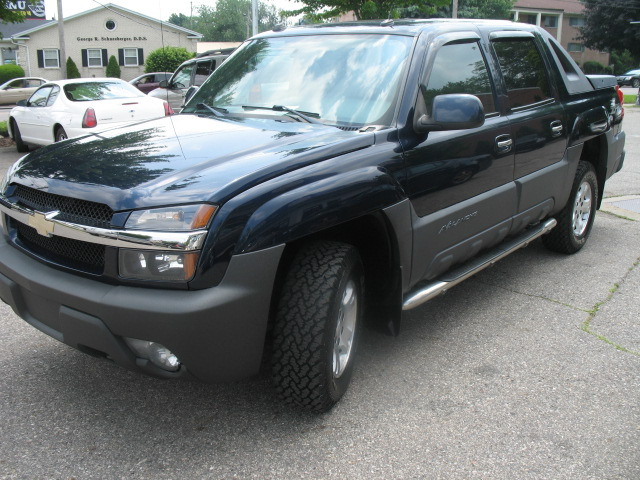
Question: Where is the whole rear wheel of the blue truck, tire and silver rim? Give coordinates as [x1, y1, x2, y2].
[542, 161, 598, 253]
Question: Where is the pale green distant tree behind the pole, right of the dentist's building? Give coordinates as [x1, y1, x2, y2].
[193, 0, 284, 42]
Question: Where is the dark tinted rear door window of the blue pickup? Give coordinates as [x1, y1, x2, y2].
[492, 38, 551, 108]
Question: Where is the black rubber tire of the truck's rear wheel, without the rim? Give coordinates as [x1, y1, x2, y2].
[542, 161, 599, 254]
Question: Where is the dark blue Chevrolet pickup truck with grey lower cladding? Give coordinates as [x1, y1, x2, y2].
[0, 20, 625, 411]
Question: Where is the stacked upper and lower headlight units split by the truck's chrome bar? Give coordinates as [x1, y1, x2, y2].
[118, 204, 216, 282]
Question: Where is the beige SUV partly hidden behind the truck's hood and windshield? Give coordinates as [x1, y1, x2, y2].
[149, 48, 234, 112]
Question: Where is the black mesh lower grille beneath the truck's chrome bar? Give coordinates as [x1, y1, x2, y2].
[11, 220, 105, 275]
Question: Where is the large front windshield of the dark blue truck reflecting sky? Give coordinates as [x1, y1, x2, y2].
[183, 34, 413, 126]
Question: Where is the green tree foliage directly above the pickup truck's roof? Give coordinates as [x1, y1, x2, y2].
[285, 0, 450, 20]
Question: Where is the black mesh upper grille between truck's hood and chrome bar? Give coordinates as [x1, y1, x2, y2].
[14, 185, 113, 228]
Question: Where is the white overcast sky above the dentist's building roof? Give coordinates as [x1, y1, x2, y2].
[44, 0, 301, 20]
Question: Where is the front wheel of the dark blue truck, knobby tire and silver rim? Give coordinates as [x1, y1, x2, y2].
[271, 242, 364, 412]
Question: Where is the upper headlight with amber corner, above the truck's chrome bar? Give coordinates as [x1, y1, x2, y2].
[125, 204, 216, 232]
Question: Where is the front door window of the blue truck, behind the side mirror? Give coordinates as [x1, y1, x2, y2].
[423, 42, 496, 113]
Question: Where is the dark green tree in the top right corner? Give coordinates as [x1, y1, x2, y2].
[580, 0, 640, 57]
